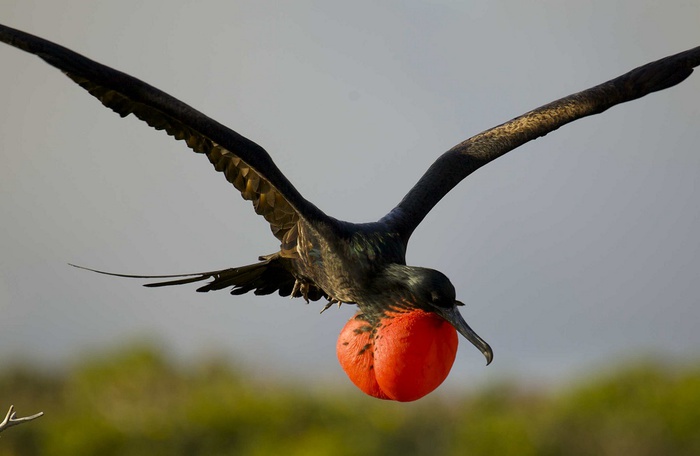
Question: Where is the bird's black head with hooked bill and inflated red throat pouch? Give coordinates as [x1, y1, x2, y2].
[337, 265, 493, 402]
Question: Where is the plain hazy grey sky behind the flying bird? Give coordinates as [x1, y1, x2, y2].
[0, 0, 700, 387]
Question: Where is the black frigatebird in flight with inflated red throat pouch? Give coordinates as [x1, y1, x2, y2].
[0, 25, 700, 401]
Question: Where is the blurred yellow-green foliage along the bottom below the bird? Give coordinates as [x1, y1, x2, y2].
[0, 345, 700, 456]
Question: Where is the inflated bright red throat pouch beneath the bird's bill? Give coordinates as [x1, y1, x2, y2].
[337, 310, 458, 402]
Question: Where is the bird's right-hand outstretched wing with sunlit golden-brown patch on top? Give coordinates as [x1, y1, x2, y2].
[383, 47, 700, 242]
